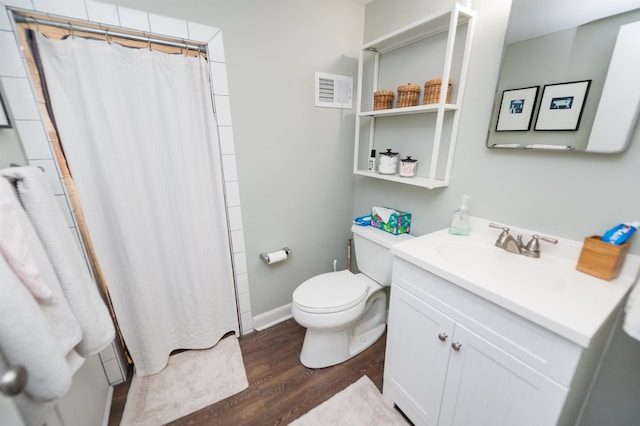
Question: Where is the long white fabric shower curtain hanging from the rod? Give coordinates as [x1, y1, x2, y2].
[38, 35, 238, 376]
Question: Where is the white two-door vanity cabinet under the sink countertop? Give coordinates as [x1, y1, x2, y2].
[383, 258, 615, 426]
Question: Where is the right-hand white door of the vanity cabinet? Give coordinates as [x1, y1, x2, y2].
[439, 324, 568, 426]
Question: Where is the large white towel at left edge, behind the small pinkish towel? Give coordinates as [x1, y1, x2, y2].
[0, 178, 82, 401]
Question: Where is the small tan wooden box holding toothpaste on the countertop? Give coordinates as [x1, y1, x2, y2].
[576, 235, 629, 281]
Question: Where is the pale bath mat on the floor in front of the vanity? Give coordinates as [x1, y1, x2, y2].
[291, 376, 409, 426]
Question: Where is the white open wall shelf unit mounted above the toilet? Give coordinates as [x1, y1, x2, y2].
[353, 3, 475, 188]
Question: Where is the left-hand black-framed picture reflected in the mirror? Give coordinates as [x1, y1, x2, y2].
[496, 86, 540, 132]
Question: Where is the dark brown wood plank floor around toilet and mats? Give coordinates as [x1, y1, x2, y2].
[109, 319, 386, 426]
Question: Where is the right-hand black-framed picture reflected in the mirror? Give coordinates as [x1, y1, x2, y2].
[535, 80, 591, 130]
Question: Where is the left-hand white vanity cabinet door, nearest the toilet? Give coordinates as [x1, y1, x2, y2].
[384, 286, 454, 425]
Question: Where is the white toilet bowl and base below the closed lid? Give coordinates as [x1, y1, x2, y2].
[300, 290, 387, 368]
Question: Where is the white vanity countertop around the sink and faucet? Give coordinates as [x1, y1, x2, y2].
[391, 217, 640, 347]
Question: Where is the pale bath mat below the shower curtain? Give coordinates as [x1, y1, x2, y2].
[120, 335, 249, 426]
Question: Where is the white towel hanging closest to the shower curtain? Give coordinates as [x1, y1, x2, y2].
[0, 167, 115, 357]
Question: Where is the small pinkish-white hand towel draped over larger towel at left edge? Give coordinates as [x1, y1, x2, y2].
[0, 179, 53, 301]
